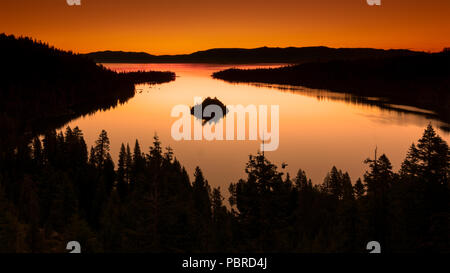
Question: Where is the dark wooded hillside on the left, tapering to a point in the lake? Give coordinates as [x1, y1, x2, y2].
[0, 34, 175, 146]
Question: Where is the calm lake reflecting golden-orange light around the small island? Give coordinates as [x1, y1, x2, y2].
[66, 64, 449, 192]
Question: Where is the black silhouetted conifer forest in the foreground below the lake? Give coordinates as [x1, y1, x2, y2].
[0, 125, 450, 253]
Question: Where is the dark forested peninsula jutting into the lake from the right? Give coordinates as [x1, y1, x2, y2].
[213, 49, 450, 122]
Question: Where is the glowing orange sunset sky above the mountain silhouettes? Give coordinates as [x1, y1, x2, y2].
[0, 0, 450, 54]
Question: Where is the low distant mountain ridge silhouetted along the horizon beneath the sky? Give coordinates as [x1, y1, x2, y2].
[83, 46, 425, 63]
